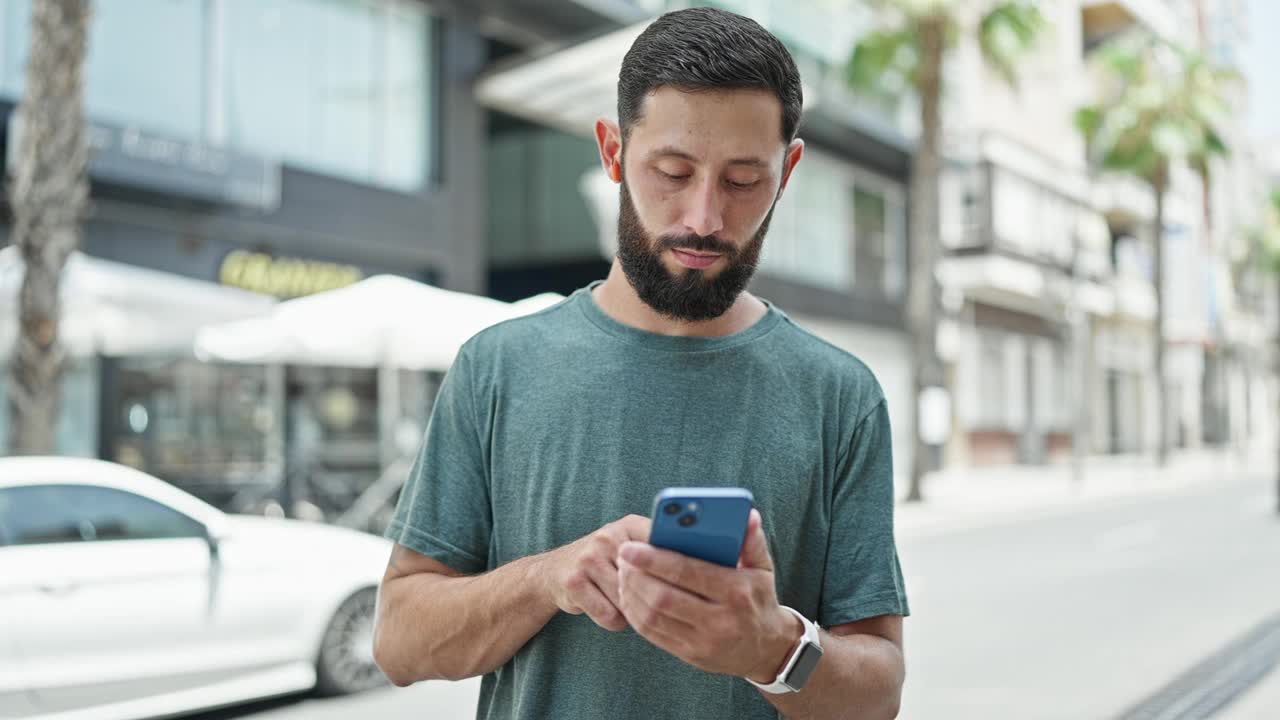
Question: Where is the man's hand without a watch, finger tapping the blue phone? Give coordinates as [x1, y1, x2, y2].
[540, 515, 652, 630]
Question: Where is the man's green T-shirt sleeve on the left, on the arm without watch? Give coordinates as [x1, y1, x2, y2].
[384, 347, 493, 574]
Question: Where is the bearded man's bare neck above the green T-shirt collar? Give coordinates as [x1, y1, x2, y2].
[591, 259, 768, 337]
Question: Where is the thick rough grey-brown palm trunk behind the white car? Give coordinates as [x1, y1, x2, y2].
[9, 0, 90, 455]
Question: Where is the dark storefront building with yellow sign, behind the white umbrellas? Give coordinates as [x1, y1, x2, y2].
[0, 0, 485, 516]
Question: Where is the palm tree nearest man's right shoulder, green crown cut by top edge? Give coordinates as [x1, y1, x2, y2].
[847, 0, 1044, 502]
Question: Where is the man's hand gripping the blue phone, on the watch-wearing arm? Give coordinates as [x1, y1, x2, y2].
[618, 510, 804, 683]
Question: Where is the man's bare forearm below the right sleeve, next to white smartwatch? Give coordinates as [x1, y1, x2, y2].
[753, 615, 906, 720]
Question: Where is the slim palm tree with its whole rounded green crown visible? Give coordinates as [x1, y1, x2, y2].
[1075, 35, 1233, 465]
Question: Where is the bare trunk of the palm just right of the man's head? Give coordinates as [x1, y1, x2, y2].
[906, 17, 946, 502]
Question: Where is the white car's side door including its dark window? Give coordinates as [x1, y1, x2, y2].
[0, 484, 215, 711]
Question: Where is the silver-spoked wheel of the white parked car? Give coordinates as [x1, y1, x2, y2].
[316, 588, 387, 696]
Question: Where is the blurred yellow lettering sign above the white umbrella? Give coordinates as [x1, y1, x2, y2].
[218, 250, 365, 297]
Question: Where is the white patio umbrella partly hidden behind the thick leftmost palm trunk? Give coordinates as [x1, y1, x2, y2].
[0, 246, 275, 357]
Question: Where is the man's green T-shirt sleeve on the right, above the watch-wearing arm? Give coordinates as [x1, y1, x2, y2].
[818, 400, 910, 628]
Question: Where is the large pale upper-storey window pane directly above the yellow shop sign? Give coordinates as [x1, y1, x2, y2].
[221, 0, 429, 190]
